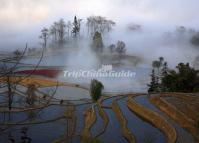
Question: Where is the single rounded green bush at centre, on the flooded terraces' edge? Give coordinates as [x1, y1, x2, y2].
[90, 79, 104, 101]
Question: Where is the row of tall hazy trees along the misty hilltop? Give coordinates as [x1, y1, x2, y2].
[39, 16, 115, 47]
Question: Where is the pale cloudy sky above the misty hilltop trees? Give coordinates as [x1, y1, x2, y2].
[0, 0, 199, 49]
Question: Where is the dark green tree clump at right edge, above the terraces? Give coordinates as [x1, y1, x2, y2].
[148, 58, 199, 92]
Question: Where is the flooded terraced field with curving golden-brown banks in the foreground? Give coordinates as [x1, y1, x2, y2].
[0, 78, 199, 143]
